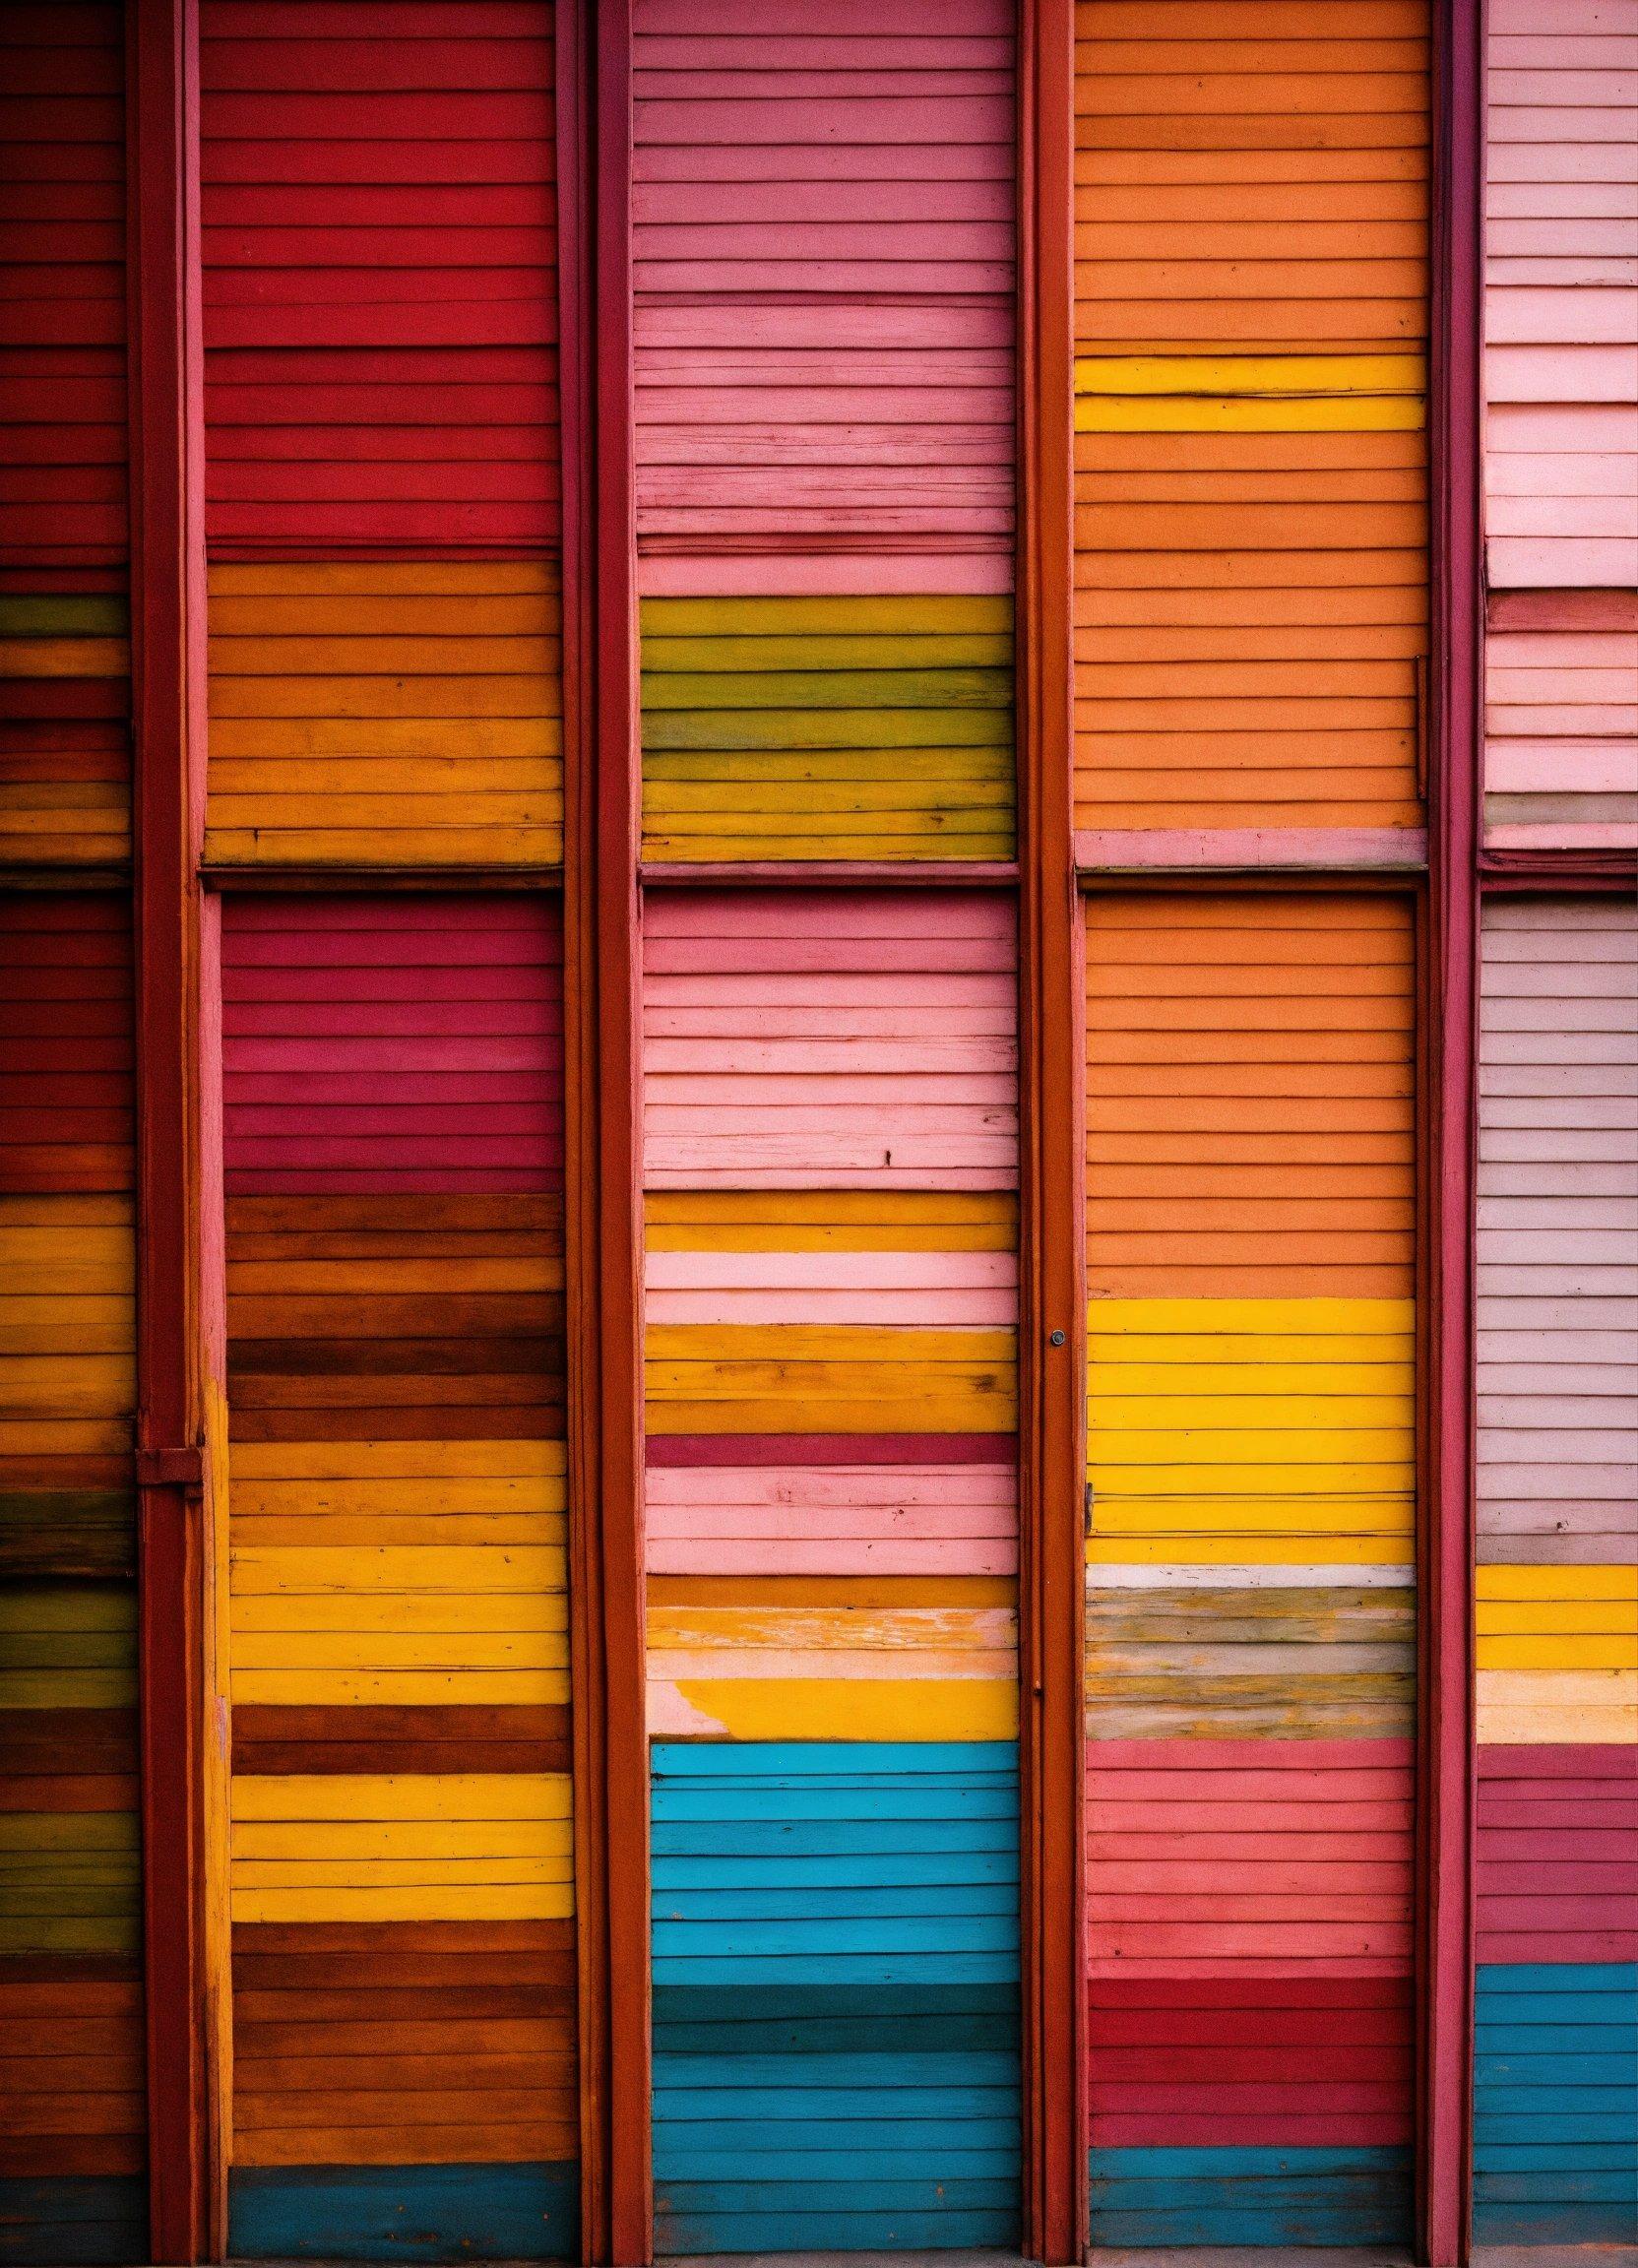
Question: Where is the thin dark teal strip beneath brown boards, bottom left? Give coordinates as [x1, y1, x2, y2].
[226, 2162, 581, 2261]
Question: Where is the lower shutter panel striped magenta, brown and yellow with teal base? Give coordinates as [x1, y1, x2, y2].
[222, 894, 579, 2259]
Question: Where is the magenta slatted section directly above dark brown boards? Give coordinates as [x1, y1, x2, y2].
[222, 894, 563, 1195]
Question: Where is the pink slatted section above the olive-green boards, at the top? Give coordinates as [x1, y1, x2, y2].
[633, 0, 1014, 576]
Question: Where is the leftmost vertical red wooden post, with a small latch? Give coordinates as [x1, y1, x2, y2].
[127, 0, 220, 2261]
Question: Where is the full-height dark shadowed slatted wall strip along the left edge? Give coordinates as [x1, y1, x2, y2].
[0, 0, 148, 2261]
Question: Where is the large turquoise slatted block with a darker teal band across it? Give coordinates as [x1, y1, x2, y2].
[654, 1741, 1021, 2254]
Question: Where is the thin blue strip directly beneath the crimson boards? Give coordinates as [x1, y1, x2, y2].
[1092, 2146, 1412, 2247]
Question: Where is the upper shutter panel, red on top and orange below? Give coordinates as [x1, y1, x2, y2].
[202, 0, 563, 868]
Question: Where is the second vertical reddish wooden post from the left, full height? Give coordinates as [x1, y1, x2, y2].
[558, 0, 654, 2268]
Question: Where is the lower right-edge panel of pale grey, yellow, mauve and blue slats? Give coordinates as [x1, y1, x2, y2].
[1475, 898, 1638, 2247]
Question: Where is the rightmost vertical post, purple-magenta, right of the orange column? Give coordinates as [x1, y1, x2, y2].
[1416, 0, 1483, 2268]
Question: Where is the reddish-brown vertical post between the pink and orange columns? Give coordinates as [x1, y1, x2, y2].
[1019, 0, 1087, 2263]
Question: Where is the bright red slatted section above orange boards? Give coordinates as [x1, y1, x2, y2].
[200, 0, 558, 560]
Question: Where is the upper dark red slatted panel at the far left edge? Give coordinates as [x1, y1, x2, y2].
[0, 0, 129, 868]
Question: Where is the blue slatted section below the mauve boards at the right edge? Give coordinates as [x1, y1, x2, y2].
[1473, 1962, 1638, 2245]
